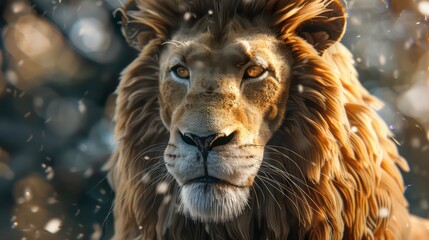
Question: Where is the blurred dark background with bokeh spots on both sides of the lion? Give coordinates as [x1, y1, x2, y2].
[0, 0, 429, 239]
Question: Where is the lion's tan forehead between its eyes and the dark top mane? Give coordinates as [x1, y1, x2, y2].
[161, 33, 284, 67]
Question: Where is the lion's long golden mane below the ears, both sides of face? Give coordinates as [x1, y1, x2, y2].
[110, 38, 408, 239]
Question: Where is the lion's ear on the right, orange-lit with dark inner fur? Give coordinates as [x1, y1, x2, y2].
[296, 0, 346, 54]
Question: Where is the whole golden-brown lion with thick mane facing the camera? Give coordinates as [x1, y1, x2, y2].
[109, 0, 423, 239]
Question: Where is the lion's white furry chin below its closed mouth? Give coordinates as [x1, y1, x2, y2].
[180, 183, 249, 223]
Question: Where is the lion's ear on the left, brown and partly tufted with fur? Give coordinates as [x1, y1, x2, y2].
[117, 0, 177, 50]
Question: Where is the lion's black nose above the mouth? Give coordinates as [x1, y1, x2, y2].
[180, 132, 236, 153]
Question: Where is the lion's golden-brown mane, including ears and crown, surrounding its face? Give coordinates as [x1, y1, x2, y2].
[110, 0, 428, 239]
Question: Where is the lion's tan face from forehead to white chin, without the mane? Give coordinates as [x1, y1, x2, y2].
[160, 33, 289, 222]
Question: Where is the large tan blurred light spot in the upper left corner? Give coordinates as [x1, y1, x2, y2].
[3, 1, 80, 90]
